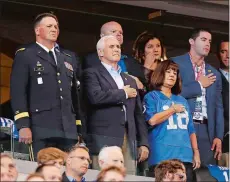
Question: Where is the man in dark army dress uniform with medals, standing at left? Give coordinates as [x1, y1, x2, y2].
[10, 13, 82, 156]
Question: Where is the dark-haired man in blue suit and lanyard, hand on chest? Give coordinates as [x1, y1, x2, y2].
[172, 29, 224, 165]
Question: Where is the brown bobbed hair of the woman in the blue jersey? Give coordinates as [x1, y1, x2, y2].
[150, 59, 181, 95]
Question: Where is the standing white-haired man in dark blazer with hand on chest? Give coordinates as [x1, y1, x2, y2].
[83, 35, 148, 174]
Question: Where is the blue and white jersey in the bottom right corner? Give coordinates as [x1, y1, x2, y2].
[207, 164, 229, 182]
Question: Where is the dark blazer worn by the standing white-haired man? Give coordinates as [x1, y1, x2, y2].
[83, 64, 148, 154]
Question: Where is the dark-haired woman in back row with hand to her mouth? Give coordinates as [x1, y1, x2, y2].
[133, 31, 167, 90]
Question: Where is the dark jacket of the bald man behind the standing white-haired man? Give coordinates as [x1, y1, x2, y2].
[82, 52, 145, 83]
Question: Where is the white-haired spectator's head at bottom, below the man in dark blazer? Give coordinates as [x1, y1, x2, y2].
[98, 146, 125, 169]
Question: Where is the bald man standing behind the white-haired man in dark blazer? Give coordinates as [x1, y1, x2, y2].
[82, 21, 145, 89]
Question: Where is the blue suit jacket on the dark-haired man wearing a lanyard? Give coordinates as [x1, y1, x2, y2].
[172, 53, 224, 143]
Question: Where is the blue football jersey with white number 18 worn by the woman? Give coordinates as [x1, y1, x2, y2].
[143, 91, 195, 165]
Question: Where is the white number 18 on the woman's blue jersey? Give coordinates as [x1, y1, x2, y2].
[163, 105, 189, 130]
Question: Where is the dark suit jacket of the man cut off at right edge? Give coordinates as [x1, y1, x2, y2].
[220, 69, 229, 152]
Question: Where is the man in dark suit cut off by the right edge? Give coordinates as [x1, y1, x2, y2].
[217, 40, 229, 166]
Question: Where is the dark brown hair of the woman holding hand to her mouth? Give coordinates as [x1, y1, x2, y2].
[133, 31, 166, 64]
